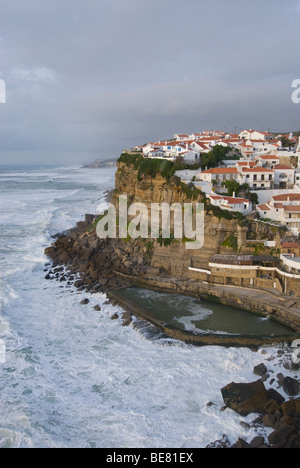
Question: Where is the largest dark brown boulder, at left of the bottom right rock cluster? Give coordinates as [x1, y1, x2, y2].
[221, 380, 269, 416]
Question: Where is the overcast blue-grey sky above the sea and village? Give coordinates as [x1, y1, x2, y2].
[0, 0, 300, 164]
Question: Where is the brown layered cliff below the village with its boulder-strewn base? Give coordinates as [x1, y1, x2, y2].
[45, 164, 300, 336]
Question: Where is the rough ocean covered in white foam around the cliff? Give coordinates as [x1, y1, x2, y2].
[0, 166, 292, 448]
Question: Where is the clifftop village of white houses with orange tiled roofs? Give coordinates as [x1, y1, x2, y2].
[124, 130, 300, 296]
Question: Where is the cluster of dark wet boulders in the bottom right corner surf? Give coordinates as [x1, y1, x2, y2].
[213, 354, 300, 448]
